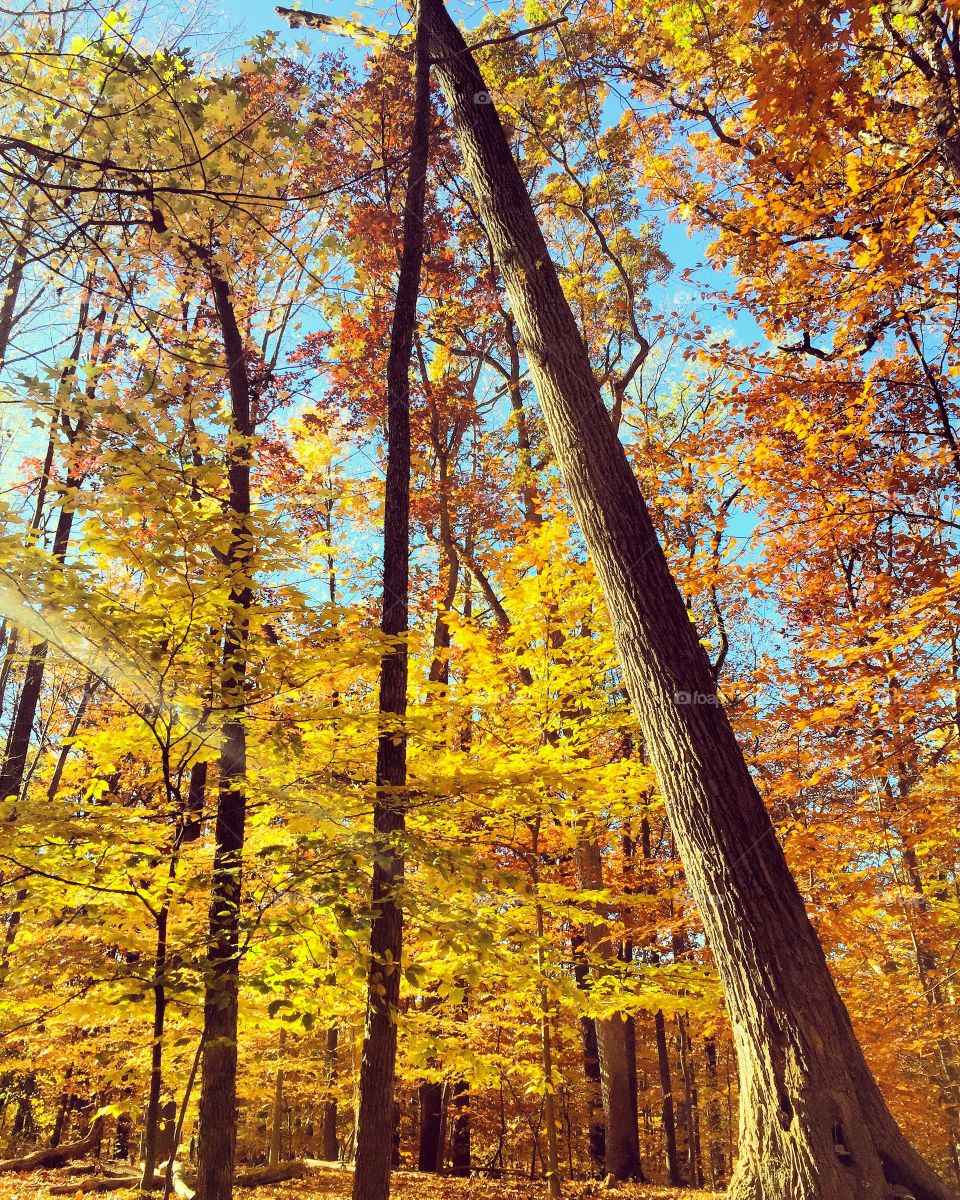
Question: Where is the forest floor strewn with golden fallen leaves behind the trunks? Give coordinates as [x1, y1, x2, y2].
[0, 1164, 715, 1200]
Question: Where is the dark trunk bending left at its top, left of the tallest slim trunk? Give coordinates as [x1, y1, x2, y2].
[197, 267, 254, 1200]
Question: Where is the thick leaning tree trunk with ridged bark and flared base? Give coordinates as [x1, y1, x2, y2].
[421, 0, 952, 1200]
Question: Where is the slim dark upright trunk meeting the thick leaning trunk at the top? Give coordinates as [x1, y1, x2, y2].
[353, 19, 430, 1200]
